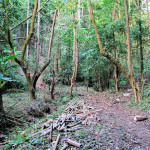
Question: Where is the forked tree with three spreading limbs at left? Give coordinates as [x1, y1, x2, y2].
[5, 0, 57, 100]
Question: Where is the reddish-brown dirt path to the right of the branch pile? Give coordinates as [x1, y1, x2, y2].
[76, 90, 150, 150]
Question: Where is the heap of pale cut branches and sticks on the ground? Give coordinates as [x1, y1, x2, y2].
[29, 101, 102, 150]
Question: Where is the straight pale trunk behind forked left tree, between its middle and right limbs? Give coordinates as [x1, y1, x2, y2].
[36, 0, 41, 71]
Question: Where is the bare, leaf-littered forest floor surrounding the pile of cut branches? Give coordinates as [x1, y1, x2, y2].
[1, 83, 150, 150]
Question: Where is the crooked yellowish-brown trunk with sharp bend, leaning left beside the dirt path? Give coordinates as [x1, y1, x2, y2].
[88, 0, 141, 102]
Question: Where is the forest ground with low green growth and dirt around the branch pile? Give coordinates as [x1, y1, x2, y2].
[0, 86, 150, 150]
